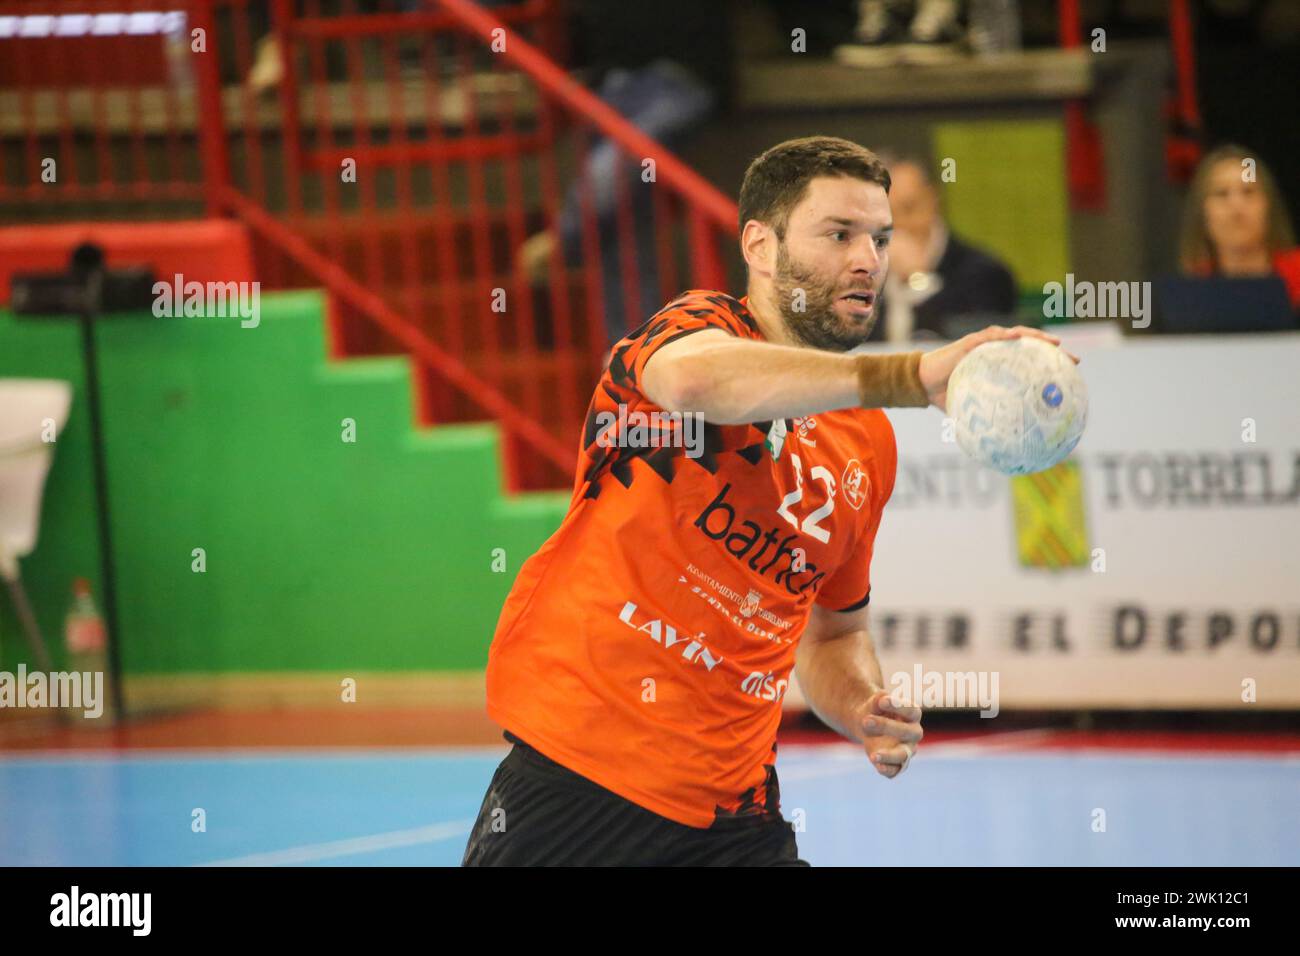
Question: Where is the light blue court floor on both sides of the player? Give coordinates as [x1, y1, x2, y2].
[0, 745, 1300, 866]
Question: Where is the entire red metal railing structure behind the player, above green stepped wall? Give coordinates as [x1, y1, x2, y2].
[0, 0, 736, 488]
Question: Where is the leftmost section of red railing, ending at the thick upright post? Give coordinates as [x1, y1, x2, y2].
[0, 0, 203, 209]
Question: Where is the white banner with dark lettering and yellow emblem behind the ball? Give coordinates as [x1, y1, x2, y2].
[795, 326, 1300, 710]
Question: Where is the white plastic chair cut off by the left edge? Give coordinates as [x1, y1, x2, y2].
[0, 378, 73, 672]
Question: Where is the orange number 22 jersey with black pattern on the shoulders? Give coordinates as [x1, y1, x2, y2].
[488, 290, 897, 827]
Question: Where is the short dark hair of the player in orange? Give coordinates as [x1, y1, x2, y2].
[740, 137, 889, 239]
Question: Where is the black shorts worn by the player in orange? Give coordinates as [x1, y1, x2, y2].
[462, 734, 809, 866]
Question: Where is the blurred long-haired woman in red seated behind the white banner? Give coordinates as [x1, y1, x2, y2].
[1179, 146, 1300, 310]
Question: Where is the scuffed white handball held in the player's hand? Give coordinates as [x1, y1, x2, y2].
[946, 338, 1088, 475]
